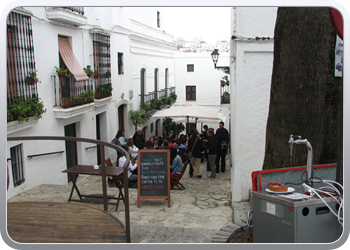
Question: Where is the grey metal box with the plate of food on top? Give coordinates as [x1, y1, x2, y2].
[253, 192, 342, 243]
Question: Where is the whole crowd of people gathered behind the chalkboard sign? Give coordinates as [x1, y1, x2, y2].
[112, 122, 230, 187]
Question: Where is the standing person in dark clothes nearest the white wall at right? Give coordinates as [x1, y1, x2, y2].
[215, 121, 230, 173]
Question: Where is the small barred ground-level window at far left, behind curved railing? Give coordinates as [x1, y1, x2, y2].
[10, 144, 24, 187]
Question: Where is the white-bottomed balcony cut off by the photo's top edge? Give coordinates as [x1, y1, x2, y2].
[46, 7, 87, 26]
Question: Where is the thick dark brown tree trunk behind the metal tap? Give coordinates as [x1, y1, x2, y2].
[263, 7, 343, 172]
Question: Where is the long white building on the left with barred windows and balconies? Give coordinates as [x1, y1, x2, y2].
[6, 7, 175, 198]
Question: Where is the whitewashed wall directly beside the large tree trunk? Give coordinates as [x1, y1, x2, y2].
[230, 7, 277, 201]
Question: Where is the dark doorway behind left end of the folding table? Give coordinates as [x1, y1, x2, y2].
[64, 123, 78, 183]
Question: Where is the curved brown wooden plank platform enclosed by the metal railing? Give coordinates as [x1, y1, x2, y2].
[7, 202, 126, 243]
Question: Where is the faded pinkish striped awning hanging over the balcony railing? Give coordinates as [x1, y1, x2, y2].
[58, 37, 89, 82]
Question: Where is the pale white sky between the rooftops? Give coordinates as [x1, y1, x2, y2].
[163, 7, 231, 43]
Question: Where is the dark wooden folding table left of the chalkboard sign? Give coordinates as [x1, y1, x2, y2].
[62, 165, 125, 211]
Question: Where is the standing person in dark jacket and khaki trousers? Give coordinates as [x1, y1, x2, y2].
[188, 130, 204, 178]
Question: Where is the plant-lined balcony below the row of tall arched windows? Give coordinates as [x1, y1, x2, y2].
[140, 87, 177, 116]
